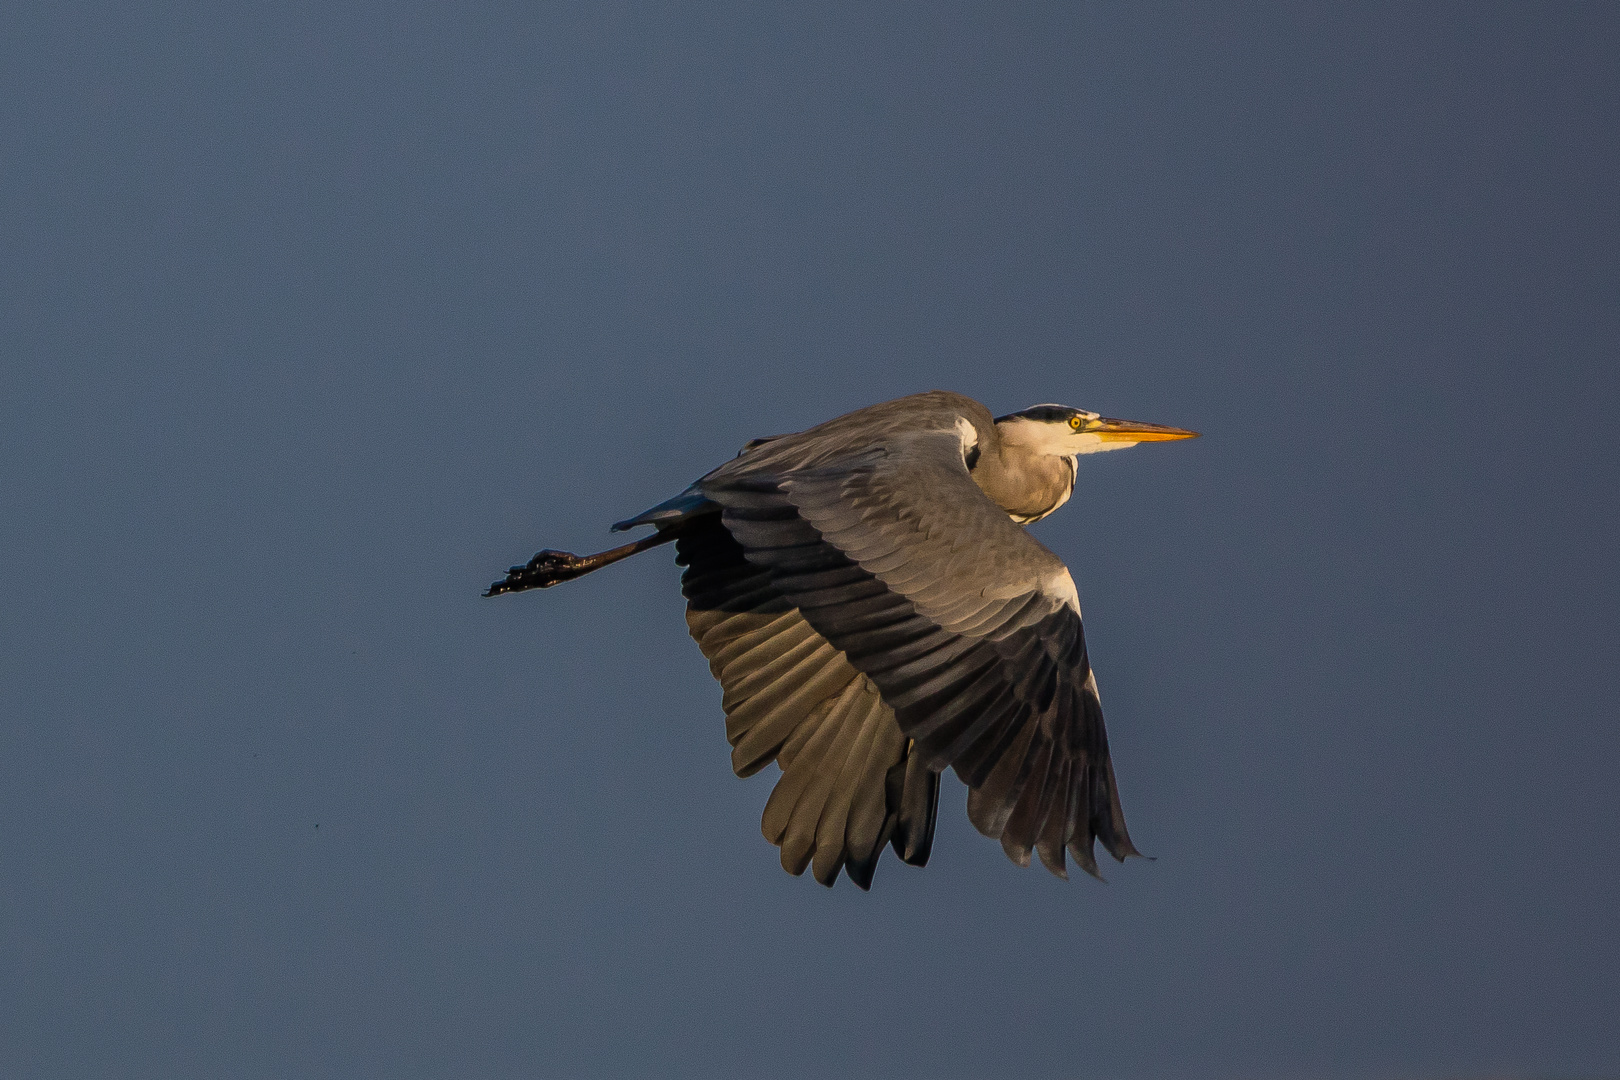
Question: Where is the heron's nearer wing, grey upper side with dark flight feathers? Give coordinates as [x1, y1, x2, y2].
[697, 395, 1137, 876]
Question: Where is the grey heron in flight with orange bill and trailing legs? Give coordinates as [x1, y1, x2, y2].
[484, 390, 1197, 889]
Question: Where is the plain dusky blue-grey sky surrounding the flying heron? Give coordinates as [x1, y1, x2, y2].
[0, 3, 1620, 1080]
